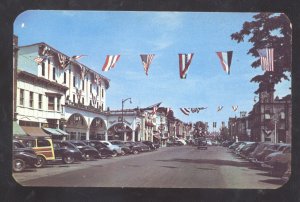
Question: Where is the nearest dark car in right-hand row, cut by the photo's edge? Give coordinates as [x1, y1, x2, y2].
[262, 145, 291, 176]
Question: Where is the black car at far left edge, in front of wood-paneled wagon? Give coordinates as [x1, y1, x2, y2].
[12, 140, 37, 172]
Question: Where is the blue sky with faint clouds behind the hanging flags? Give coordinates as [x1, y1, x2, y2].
[14, 10, 291, 129]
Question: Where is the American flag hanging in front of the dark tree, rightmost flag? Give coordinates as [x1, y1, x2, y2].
[257, 48, 274, 71]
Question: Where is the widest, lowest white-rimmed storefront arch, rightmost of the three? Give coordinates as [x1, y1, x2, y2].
[107, 123, 132, 141]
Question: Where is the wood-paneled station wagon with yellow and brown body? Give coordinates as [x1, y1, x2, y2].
[18, 137, 55, 168]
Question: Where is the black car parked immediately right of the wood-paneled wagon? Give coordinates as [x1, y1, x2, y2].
[53, 140, 82, 164]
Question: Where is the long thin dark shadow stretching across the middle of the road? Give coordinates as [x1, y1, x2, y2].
[156, 159, 251, 167]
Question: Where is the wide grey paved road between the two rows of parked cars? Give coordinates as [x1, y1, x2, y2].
[14, 146, 282, 189]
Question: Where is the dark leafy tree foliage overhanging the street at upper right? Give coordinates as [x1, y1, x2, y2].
[231, 13, 292, 94]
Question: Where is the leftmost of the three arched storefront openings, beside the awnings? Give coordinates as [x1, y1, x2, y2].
[66, 113, 88, 140]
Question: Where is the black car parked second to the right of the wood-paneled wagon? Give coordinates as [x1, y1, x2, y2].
[69, 140, 101, 160]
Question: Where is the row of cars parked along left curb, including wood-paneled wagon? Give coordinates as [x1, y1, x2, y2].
[12, 137, 159, 172]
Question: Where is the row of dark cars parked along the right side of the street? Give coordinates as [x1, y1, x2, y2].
[222, 141, 291, 180]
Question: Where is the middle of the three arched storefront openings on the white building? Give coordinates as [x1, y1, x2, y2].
[90, 117, 106, 140]
